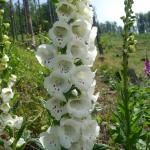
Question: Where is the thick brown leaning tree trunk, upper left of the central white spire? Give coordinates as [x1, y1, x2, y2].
[23, 0, 35, 46]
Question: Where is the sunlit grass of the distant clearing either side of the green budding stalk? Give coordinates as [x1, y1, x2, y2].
[96, 33, 150, 77]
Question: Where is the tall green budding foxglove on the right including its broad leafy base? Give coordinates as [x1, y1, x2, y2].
[112, 0, 146, 150]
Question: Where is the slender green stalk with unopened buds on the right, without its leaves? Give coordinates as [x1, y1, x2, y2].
[122, 0, 134, 150]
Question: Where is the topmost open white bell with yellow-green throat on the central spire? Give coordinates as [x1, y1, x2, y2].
[56, 1, 75, 22]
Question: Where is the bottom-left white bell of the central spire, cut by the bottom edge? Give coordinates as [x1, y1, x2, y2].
[39, 127, 61, 150]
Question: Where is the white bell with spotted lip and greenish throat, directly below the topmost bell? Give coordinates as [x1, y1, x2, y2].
[49, 21, 71, 48]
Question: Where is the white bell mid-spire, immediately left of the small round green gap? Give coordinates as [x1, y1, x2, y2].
[53, 55, 74, 75]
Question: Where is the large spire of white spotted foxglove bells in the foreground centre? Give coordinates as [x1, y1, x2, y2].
[36, 0, 99, 150]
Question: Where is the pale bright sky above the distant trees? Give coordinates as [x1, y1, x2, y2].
[13, 0, 150, 25]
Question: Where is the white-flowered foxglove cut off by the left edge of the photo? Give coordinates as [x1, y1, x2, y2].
[0, 0, 25, 150]
